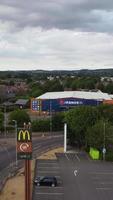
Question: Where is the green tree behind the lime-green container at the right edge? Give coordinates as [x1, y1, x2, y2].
[86, 119, 113, 160]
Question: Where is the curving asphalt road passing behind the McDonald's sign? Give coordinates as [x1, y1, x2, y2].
[0, 136, 63, 172]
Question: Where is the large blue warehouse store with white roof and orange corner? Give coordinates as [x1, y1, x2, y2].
[31, 91, 113, 114]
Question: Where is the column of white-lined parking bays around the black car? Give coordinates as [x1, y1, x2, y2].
[33, 160, 64, 200]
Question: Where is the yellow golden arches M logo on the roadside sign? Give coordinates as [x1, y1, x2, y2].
[18, 130, 31, 141]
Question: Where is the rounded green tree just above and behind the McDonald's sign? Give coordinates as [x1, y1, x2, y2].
[9, 109, 30, 127]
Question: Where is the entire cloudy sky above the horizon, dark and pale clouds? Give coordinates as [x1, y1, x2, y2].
[0, 0, 113, 71]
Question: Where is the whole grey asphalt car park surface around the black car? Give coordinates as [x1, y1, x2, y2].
[33, 152, 113, 200]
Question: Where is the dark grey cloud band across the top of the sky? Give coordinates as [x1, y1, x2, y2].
[0, 0, 113, 33]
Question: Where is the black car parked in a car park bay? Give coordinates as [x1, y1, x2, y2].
[34, 176, 57, 187]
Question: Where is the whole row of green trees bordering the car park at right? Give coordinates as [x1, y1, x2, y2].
[65, 105, 113, 159]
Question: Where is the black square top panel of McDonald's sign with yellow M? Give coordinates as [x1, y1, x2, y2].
[17, 129, 32, 142]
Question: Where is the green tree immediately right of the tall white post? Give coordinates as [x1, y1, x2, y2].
[65, 106, 99, 145]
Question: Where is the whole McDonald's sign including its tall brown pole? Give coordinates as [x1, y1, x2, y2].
[17, 123, 32, 200]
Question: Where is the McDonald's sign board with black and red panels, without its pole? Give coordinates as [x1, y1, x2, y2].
[17, 129, 32, 160]
